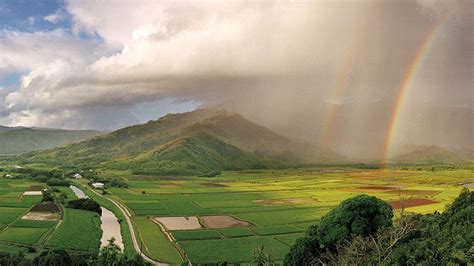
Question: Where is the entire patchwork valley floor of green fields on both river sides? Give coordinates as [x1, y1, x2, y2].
[0, 168, 474, 264]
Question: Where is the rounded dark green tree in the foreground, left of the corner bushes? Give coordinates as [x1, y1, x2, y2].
[285, 195, 393, 265]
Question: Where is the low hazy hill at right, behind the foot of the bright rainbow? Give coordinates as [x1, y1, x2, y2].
[395, 144, 473, 163]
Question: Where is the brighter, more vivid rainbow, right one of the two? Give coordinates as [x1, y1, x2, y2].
[383, 15, 448, 163]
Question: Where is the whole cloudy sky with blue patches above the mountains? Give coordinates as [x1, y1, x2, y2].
[0, 0, 474, 157]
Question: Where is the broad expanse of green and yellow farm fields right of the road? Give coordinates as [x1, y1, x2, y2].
[98, 169, 474, 263]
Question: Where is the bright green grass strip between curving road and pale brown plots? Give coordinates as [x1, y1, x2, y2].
[133, 217, 183, 264]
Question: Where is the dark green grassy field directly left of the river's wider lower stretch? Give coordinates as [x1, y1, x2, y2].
[46, 208, 102, 253]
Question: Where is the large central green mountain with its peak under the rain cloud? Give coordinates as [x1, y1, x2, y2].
[29, 109, 340, 175]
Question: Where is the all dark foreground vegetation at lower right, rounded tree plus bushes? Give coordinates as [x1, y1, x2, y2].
[285, 189, 474, 265]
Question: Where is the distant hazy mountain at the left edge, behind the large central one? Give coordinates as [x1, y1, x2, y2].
[0, 126, 101, 154]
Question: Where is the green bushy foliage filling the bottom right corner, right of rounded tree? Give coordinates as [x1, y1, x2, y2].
[388, 189, 474, 265]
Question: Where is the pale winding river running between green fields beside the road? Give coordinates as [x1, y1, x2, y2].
[69, 186, 123, 250]
